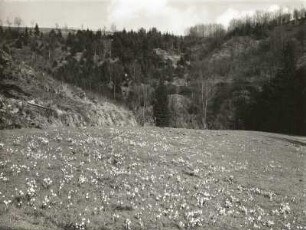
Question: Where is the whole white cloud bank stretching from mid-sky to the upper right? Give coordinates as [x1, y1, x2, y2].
[108, 0, 306, 34]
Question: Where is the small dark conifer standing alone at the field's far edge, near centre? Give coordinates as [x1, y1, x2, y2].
[153, 80, 170, 127]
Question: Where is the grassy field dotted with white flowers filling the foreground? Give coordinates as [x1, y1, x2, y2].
[0, 127, 306, 230]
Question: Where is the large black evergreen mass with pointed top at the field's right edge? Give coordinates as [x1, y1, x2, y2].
[246, 41, 305, 134]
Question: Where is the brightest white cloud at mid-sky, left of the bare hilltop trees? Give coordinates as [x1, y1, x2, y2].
[108, 0, 207, 34]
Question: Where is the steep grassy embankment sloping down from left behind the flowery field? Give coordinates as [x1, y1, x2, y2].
[0, 51, 136, 129]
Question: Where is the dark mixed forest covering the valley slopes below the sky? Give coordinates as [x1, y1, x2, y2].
[0, 8, 306, 135]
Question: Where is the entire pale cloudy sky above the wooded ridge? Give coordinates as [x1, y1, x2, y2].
[0, 0, 306, 34]
